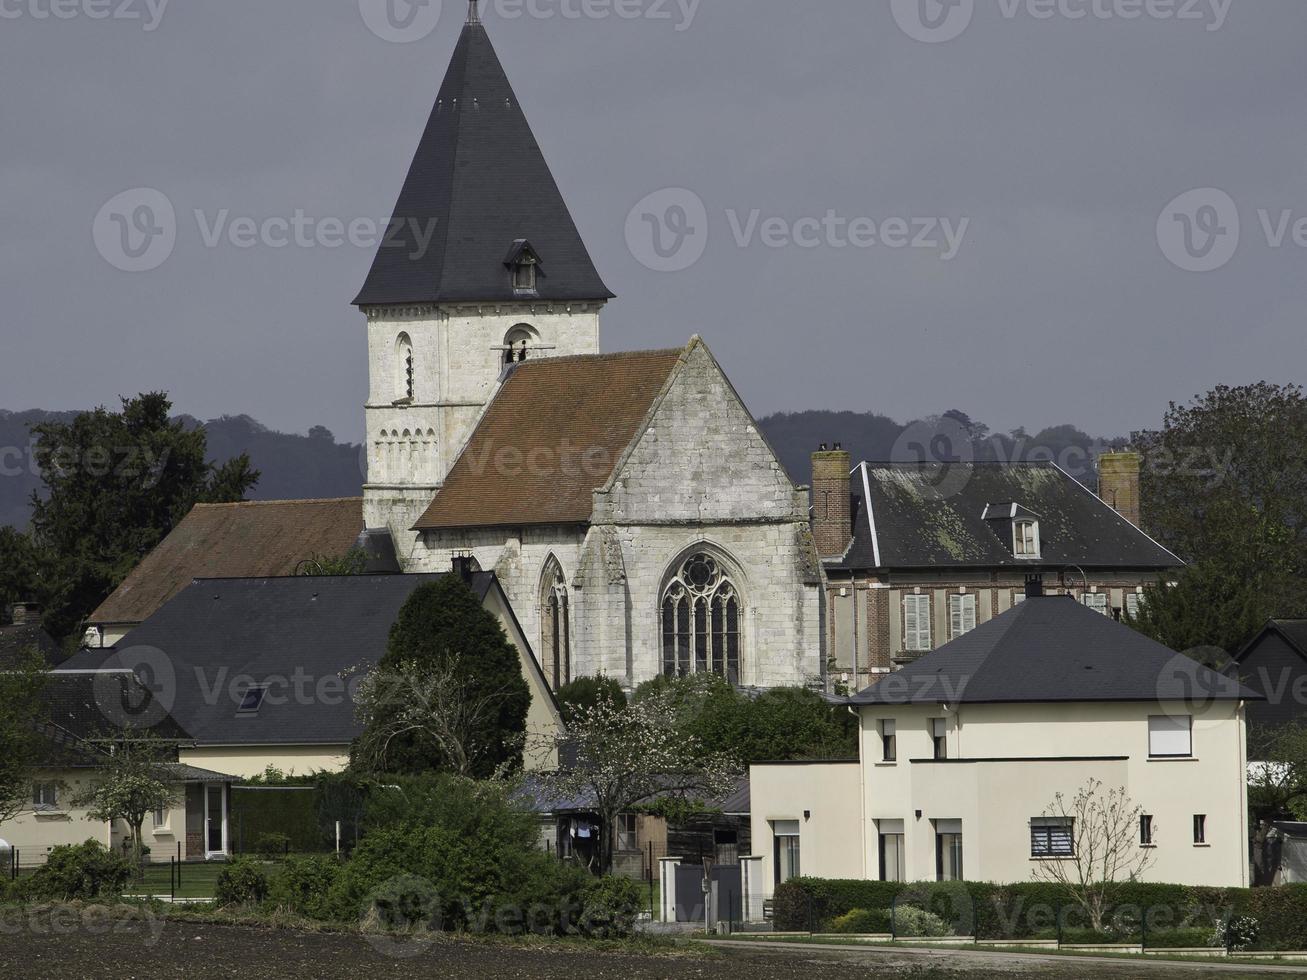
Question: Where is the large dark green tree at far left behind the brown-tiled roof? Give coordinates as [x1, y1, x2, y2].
[16, 392, 259, 638]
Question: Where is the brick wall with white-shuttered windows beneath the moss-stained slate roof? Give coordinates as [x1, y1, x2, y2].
[826, 568, 1158, 691]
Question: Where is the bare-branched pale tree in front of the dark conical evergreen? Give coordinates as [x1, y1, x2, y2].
[354, 656, 508, 776]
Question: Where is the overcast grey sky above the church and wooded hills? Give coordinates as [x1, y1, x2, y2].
[0, 0, 1307, 440]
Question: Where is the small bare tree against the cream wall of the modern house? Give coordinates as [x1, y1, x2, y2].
[1033, 779, 1157, 932]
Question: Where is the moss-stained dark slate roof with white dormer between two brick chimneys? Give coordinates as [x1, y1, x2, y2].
[827, 463, 1183, 571]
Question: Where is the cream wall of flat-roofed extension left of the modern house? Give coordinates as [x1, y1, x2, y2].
[749, 762, 867, 896]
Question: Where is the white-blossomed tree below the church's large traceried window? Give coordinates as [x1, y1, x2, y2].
[528, 691, 740, 872]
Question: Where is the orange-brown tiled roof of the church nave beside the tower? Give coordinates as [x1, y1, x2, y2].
[416, 350, 685, 531]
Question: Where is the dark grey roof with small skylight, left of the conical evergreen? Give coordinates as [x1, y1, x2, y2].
[60, 572, 498, 745]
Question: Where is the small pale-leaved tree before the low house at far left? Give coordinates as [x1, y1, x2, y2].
[73, 730, 182, 869]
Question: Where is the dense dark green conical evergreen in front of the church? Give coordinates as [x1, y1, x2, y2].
[354, 575, 531, 777]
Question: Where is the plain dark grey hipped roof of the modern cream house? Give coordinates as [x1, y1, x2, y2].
[850, 596, 1261, 704]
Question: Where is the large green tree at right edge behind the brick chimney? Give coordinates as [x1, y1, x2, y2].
[1137, 382, 1307, 652]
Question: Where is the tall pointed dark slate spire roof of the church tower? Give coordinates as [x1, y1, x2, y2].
[354, 24, 613, 306]
